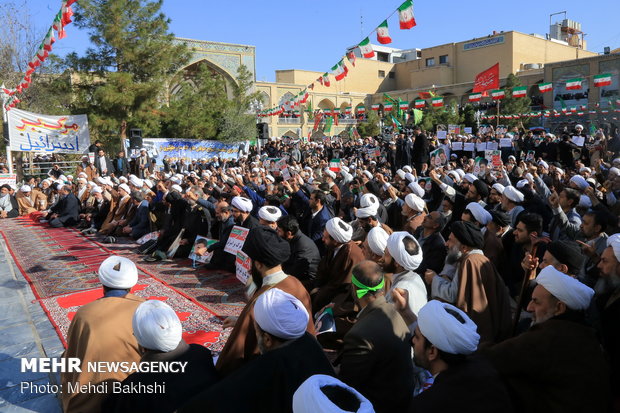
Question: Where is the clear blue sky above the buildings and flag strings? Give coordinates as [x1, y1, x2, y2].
[20, 0, 620, 81]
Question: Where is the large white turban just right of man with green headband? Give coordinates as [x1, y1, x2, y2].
[418, 300, 480, 354]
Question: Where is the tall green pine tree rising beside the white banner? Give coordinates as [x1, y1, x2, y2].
[66, 0, 189, 148]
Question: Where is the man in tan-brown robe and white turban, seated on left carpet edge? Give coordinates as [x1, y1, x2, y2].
[60, 256, 144, 413]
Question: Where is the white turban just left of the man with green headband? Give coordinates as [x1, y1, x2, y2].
[254, 288, 310, 340]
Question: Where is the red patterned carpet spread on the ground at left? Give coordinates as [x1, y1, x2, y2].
[0, 214, 245, 352]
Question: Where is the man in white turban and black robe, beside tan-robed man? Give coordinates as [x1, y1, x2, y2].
[103, 300, 218, 413]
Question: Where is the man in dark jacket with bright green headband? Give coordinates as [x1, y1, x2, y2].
[339, 261, 414, 413]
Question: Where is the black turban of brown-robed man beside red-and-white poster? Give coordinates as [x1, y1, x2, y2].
[242, 225, 291, 268]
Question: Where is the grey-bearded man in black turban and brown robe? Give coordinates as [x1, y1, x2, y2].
[425, 221, 511, 345]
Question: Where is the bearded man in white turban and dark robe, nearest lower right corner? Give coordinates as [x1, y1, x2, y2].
[483, 266, 609, 412]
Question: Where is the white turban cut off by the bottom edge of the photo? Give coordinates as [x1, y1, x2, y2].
[293, 374, 375, 413]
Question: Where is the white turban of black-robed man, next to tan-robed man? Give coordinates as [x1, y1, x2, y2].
[132, 300, 183, 352]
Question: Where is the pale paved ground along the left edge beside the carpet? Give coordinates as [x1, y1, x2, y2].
[0, 237, 63, 413]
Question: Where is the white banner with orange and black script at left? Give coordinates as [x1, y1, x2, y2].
[8, 109, 90, 154]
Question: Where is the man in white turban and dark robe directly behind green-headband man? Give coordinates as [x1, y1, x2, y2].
[310, 218, 364, 312]
